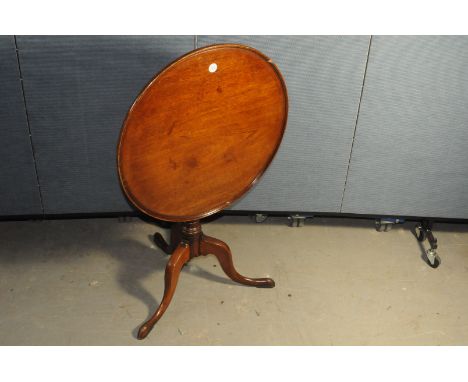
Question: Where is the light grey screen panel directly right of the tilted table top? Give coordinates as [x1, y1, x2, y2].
[197, 36, 370, 212]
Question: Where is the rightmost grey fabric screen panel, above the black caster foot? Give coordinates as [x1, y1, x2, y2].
[342, 36, 468, 219]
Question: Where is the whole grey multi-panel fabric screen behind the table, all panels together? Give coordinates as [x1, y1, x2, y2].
[0, 36, 468, 219]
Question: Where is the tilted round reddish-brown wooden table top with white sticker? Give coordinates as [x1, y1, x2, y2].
[118, 44, 288, 222]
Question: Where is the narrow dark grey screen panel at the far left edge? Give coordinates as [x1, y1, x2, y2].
[0, 36, 42, 215]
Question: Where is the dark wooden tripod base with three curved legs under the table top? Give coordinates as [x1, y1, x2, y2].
[138, 221, 275, 340]
